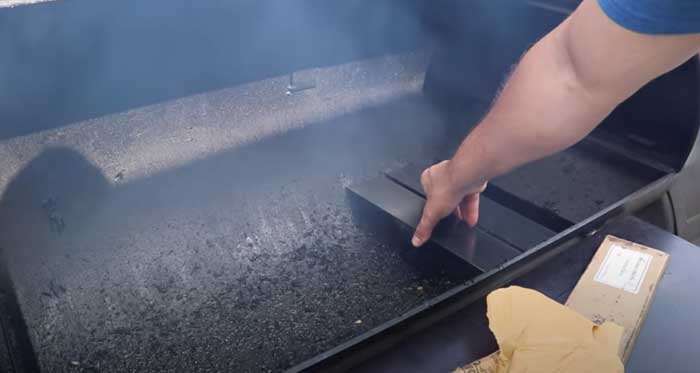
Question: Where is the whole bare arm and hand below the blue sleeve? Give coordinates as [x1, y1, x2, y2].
[412, 0, 700, 246]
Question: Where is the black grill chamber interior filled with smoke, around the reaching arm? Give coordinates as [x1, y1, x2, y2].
[0, 1, 698, 371]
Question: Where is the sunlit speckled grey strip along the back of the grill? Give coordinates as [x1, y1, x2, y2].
[0, 53, 429, 190]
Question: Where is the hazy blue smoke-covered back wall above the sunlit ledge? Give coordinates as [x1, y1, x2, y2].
[0, 0, 431, 138]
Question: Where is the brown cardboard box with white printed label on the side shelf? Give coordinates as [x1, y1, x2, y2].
[455, 236, 669, 373]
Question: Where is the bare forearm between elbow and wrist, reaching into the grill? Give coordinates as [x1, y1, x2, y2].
[451, 26, 620, 189]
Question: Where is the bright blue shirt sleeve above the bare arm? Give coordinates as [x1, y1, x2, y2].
[598, 0, 700, 34]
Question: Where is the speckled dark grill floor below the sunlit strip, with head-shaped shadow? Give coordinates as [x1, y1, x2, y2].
[2, 93, 466, 372]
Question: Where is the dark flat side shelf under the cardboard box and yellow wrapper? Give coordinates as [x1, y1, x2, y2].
[354, 217, 700, 373]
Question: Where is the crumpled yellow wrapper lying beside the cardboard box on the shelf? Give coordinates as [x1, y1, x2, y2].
[486, 286, 624, 373]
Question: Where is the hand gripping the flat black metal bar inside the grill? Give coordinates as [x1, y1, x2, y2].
[411, 161, 486, 247]
